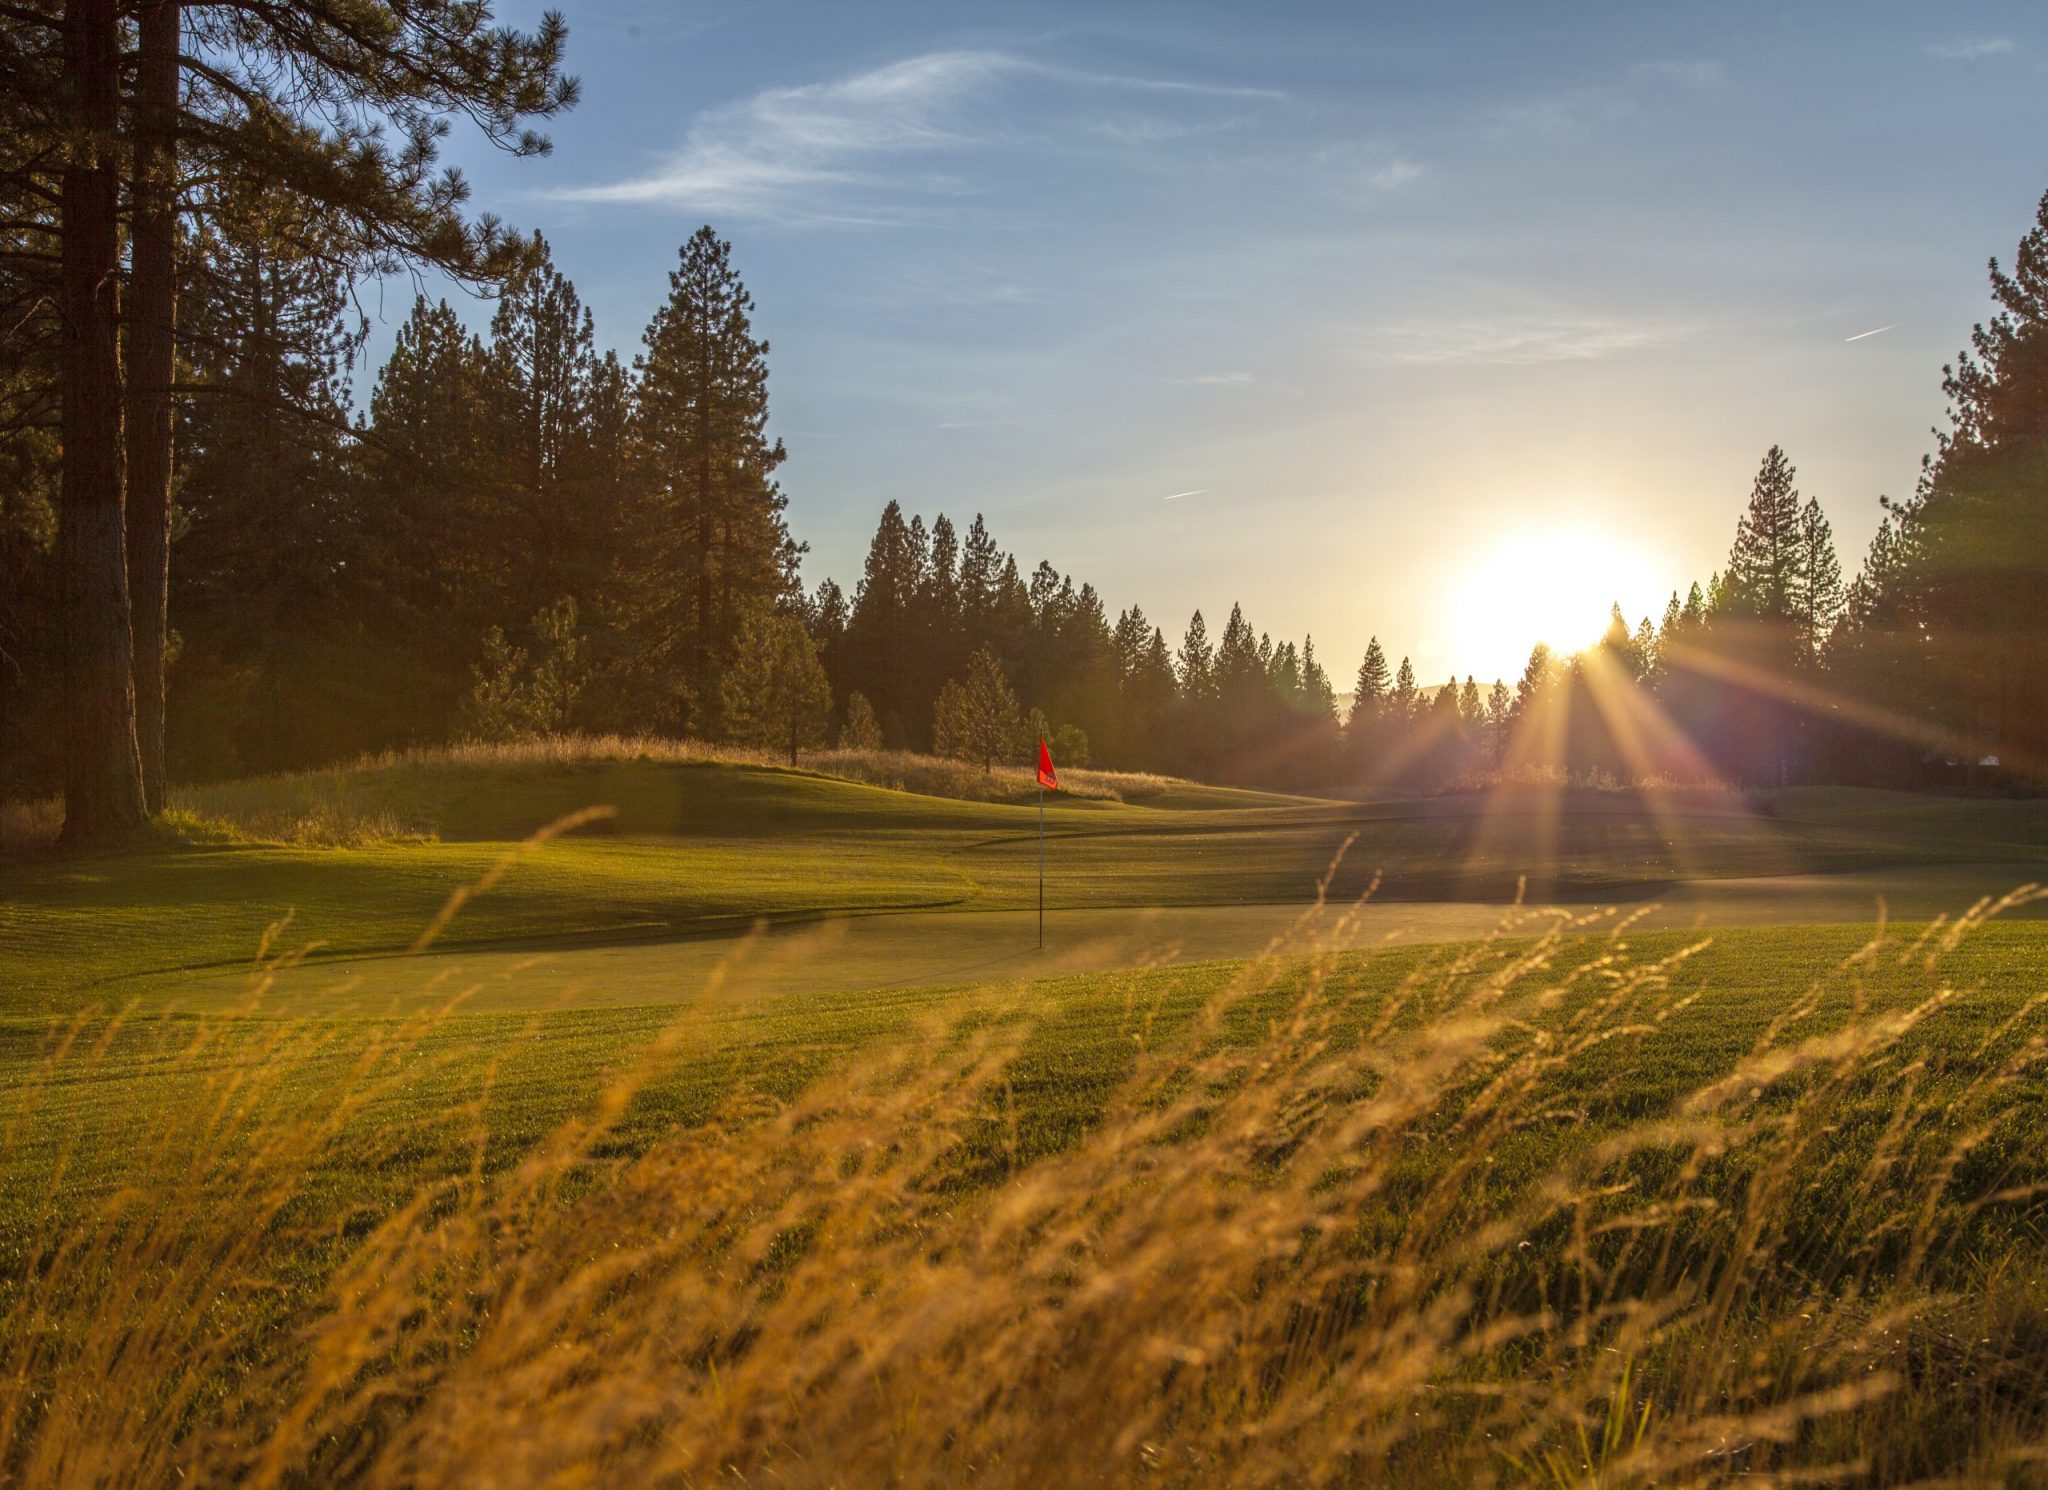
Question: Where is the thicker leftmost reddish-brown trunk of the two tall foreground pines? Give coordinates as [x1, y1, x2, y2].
[57, 0, 145, 847]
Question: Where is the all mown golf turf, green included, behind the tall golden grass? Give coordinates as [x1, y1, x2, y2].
[0, 761, 2048, 1478]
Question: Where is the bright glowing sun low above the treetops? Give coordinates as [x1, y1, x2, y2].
[1452, 530, 1655, 677]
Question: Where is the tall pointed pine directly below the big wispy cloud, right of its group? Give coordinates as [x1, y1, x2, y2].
[633, 227, 797, 733]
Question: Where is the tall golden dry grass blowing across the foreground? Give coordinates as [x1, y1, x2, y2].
[0, 843, 2048, 1486]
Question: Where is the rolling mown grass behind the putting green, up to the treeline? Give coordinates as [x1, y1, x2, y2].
[0, 753, 2048, 1013]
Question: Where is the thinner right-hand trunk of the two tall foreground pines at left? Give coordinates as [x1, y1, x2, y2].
[127, 0, 178, 815]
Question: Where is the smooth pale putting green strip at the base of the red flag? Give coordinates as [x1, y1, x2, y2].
[148, 864, 2040, 1015]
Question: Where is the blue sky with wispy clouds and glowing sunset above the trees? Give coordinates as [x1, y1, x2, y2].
[391, 0, 2048, 690]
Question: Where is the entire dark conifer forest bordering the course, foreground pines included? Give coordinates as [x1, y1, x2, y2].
[0, 0, 2048, 841]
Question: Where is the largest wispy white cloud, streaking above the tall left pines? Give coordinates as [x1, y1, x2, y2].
[553, 51, 1284, 221]
